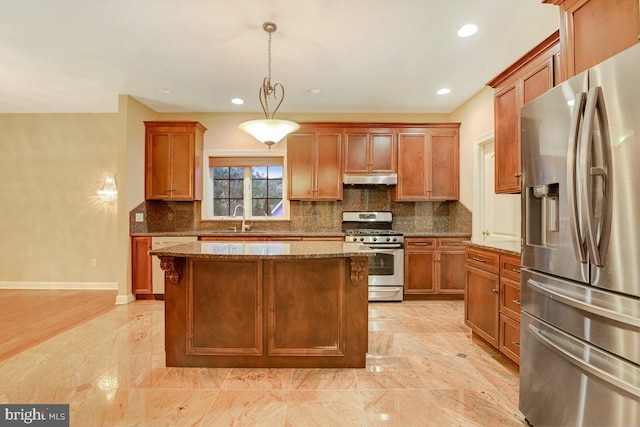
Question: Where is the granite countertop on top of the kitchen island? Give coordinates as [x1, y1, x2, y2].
[149, 241, 375, 260]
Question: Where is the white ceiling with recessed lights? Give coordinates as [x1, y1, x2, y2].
[0, 0, 559, 117]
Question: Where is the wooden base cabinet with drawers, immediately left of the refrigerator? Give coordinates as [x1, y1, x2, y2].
[464, 247, 520, 363]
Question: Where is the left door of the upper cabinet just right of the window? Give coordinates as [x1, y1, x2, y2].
[287, 133, 315, 200]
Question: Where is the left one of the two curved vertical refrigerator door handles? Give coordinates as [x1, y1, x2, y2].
[567, 92, 587, 264]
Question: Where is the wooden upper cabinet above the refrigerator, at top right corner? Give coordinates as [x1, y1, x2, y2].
[543, 0, 640, 80]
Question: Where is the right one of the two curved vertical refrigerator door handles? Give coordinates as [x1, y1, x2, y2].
[579, 86, 612, 267]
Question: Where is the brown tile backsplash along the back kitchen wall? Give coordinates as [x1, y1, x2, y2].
[130, 186, 471, 234]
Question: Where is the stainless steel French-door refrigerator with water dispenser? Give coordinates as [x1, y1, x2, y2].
[520, 45, 640, 427]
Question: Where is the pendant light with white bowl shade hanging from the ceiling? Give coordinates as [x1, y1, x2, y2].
[238, 22, 300, 150]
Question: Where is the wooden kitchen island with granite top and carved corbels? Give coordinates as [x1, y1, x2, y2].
[150, 241, 371, 368]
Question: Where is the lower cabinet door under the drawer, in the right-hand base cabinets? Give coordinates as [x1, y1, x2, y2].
[464, 265, 500, 348]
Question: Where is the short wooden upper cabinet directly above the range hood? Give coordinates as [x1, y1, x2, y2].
[344, 128, 396, 174]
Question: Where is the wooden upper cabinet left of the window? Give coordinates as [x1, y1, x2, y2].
[144, 122, 207, 200]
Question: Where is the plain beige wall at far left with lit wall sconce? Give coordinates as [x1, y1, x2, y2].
[0, 114, 121, 288]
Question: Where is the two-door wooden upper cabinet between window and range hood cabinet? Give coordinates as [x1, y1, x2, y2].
[287, 126, 342, 200]
